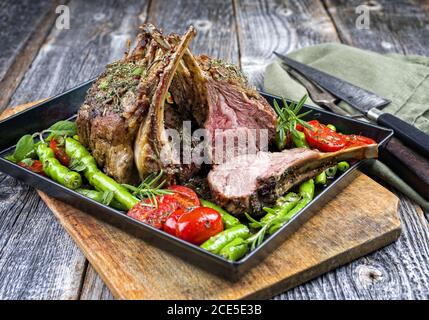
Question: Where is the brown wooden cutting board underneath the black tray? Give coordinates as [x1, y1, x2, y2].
[0, 104, 401, 299]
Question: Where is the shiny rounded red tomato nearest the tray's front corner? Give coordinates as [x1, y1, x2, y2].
[176, 207, 223, 245]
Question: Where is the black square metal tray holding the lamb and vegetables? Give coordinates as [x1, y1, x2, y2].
[0, 80, 393, 280]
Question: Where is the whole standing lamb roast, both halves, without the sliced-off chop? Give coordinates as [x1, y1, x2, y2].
[77, 24, 276, 183]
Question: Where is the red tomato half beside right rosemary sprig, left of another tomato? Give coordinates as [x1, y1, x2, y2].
[303, 120, 346, 152]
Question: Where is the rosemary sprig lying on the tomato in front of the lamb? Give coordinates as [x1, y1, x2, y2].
[122, 170, 173, 207]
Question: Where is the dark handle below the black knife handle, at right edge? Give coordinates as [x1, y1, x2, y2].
[380, 137, 429, 201]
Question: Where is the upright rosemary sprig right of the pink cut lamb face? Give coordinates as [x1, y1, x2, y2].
[273, 95, 311, 150]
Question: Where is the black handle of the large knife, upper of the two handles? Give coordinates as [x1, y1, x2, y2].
[377, 113, 429, 159]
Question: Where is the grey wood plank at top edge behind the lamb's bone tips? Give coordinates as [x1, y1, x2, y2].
[148, 0, 239, 63]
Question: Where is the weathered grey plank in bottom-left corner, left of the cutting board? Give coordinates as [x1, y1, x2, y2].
[0, 173, 86, 299]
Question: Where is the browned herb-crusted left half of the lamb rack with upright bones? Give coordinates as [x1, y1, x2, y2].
[77, 25, 195, 183]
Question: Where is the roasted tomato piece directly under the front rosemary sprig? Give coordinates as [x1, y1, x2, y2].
[128, 195, 179, 229]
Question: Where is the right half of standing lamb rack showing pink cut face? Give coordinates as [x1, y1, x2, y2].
[170, 50, 276, 164]
